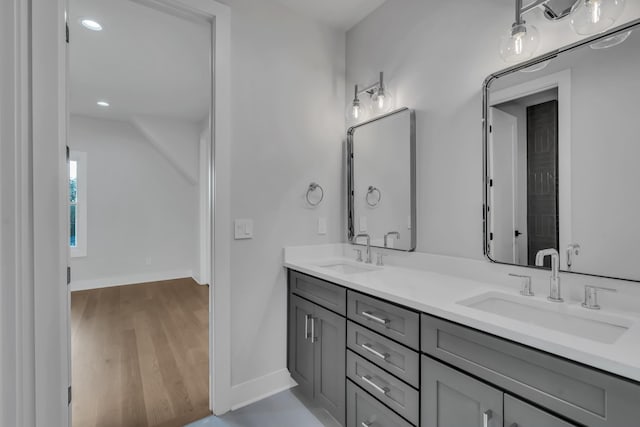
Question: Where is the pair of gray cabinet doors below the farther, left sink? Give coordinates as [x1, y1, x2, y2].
[288, 272, 347, 425]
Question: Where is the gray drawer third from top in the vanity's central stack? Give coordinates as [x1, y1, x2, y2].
[347, 350, 420, 425]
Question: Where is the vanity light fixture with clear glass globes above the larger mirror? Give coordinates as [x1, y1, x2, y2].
[500, 0, 628, 63]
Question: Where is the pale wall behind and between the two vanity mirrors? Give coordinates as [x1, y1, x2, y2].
[347, 0, 640, 258]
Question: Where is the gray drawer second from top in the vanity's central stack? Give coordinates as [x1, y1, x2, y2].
[347, 321, 420, 388]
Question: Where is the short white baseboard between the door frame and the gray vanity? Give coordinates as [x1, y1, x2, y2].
[231, 369, 296, 411]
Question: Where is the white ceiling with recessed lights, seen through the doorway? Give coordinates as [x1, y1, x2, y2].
[69, 0, 210, 122]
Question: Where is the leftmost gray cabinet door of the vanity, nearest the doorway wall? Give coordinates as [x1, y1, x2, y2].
[289, 295, 315, 398]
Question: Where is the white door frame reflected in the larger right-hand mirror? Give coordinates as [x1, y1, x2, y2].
[489, 69, 572, 270]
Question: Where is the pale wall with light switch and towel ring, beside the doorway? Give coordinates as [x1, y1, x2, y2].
[225, 0, 346, 394]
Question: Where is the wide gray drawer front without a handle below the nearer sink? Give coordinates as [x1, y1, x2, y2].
[422, 315, 640, 427]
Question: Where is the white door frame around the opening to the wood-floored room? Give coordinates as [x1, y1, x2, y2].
[25, 0, 231, 426]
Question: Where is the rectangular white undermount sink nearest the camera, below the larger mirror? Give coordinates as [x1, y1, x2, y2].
[458, 292, 633, 344]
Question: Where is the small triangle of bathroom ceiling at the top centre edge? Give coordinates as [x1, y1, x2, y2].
[268, 0, 386, 31]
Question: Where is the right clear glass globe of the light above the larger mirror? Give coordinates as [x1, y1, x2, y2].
[570, 0, 625, 36]
